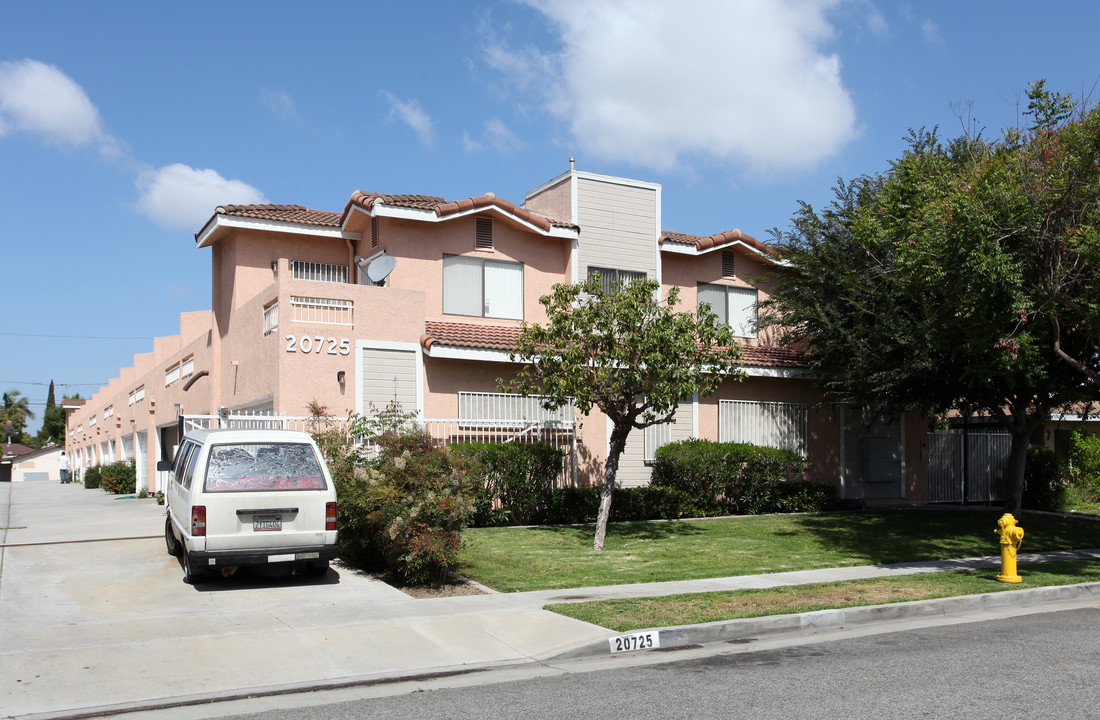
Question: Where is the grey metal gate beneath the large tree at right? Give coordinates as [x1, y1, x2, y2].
[928, 431, 1012, 502]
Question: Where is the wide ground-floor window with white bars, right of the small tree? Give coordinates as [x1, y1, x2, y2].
[718, 400, 809, 457]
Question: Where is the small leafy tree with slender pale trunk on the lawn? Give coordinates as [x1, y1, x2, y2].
[502, 277, 743, 550]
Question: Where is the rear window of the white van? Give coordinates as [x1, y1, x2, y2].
[204, 443, 325, 492]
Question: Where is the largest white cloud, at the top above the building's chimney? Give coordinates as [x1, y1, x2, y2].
[485, 0, 856, 173]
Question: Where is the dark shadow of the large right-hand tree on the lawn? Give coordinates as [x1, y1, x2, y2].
[792, 508, 1100, 565]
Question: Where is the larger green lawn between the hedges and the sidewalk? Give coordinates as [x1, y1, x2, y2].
[460, 509, 1100, 592]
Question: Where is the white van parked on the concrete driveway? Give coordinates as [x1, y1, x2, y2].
[164, 430, 337, 583]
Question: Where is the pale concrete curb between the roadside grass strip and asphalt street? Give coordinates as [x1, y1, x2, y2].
[548, 583, 1100, 662]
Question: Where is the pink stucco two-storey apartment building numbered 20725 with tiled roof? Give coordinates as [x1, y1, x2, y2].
[66, 162, 927, 501]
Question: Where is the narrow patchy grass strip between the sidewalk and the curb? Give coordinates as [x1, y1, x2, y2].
[547, 560, 1100, 632]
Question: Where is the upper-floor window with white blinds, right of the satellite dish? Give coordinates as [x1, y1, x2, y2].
[443, 255, 524, 320]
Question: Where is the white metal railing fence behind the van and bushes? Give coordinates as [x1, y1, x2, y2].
[184, 412, 576, 487]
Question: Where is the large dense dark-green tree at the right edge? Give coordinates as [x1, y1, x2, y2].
[766, 82, 1100, 512]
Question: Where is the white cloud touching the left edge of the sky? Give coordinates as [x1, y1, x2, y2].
[0, 59, 119, 156]
